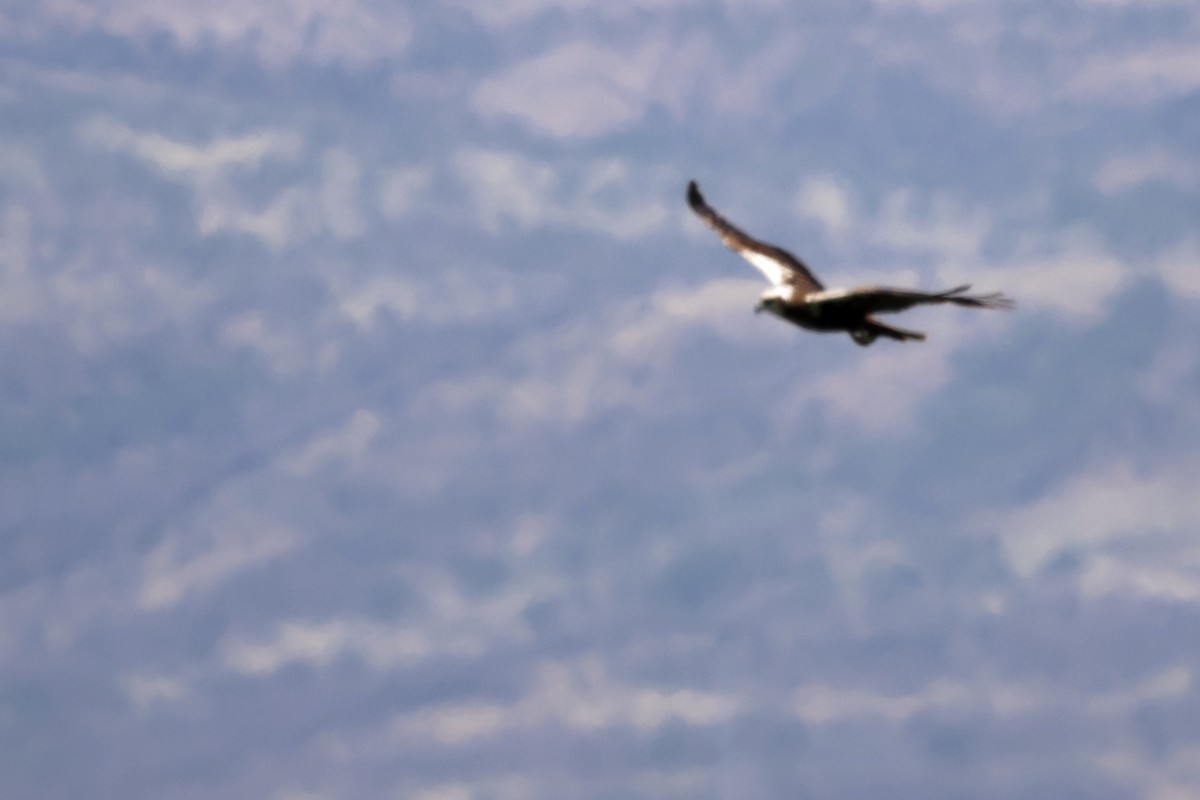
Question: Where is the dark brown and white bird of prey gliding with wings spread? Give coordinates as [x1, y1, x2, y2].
[688, 181, 1013, 347]
